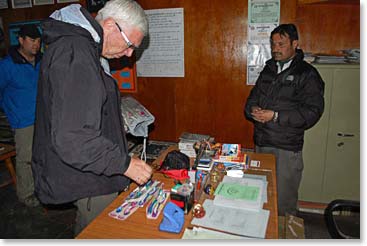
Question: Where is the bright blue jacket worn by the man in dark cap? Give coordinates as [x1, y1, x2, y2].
[0, 47, 41, 128]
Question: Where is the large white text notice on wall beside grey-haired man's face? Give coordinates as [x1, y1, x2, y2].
[136, 8, 185, 77]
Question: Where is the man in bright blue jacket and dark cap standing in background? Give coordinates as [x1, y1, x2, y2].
[0, 24, 41, 207]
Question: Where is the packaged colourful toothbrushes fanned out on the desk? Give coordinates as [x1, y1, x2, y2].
[108, 180, 169, 220]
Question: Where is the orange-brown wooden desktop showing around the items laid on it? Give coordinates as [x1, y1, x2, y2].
[77, 150, 278, 239]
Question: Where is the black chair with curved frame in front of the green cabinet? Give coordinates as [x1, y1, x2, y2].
[324, 199, 360, 239]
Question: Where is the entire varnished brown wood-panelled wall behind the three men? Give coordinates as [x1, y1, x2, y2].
[0, 0, 360, 148]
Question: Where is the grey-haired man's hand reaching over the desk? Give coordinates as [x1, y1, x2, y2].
[124, 157, 153, 185]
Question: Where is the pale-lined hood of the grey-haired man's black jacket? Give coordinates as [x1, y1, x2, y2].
[42, 4, 103, 50]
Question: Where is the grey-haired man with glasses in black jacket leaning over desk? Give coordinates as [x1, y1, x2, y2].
[32, 0, 152, 235]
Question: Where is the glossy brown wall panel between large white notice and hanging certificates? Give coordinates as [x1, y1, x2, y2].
[176, 0, 251, 143]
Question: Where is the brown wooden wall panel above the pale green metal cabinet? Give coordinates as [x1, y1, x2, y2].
[296, 0, 360, 55]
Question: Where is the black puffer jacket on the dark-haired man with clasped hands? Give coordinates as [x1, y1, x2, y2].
[245, 49, 324, 151]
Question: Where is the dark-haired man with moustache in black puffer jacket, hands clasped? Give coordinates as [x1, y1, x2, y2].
[245, 24, 324, 216]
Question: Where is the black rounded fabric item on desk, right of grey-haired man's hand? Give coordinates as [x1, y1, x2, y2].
[160, 150, 190, 170]
